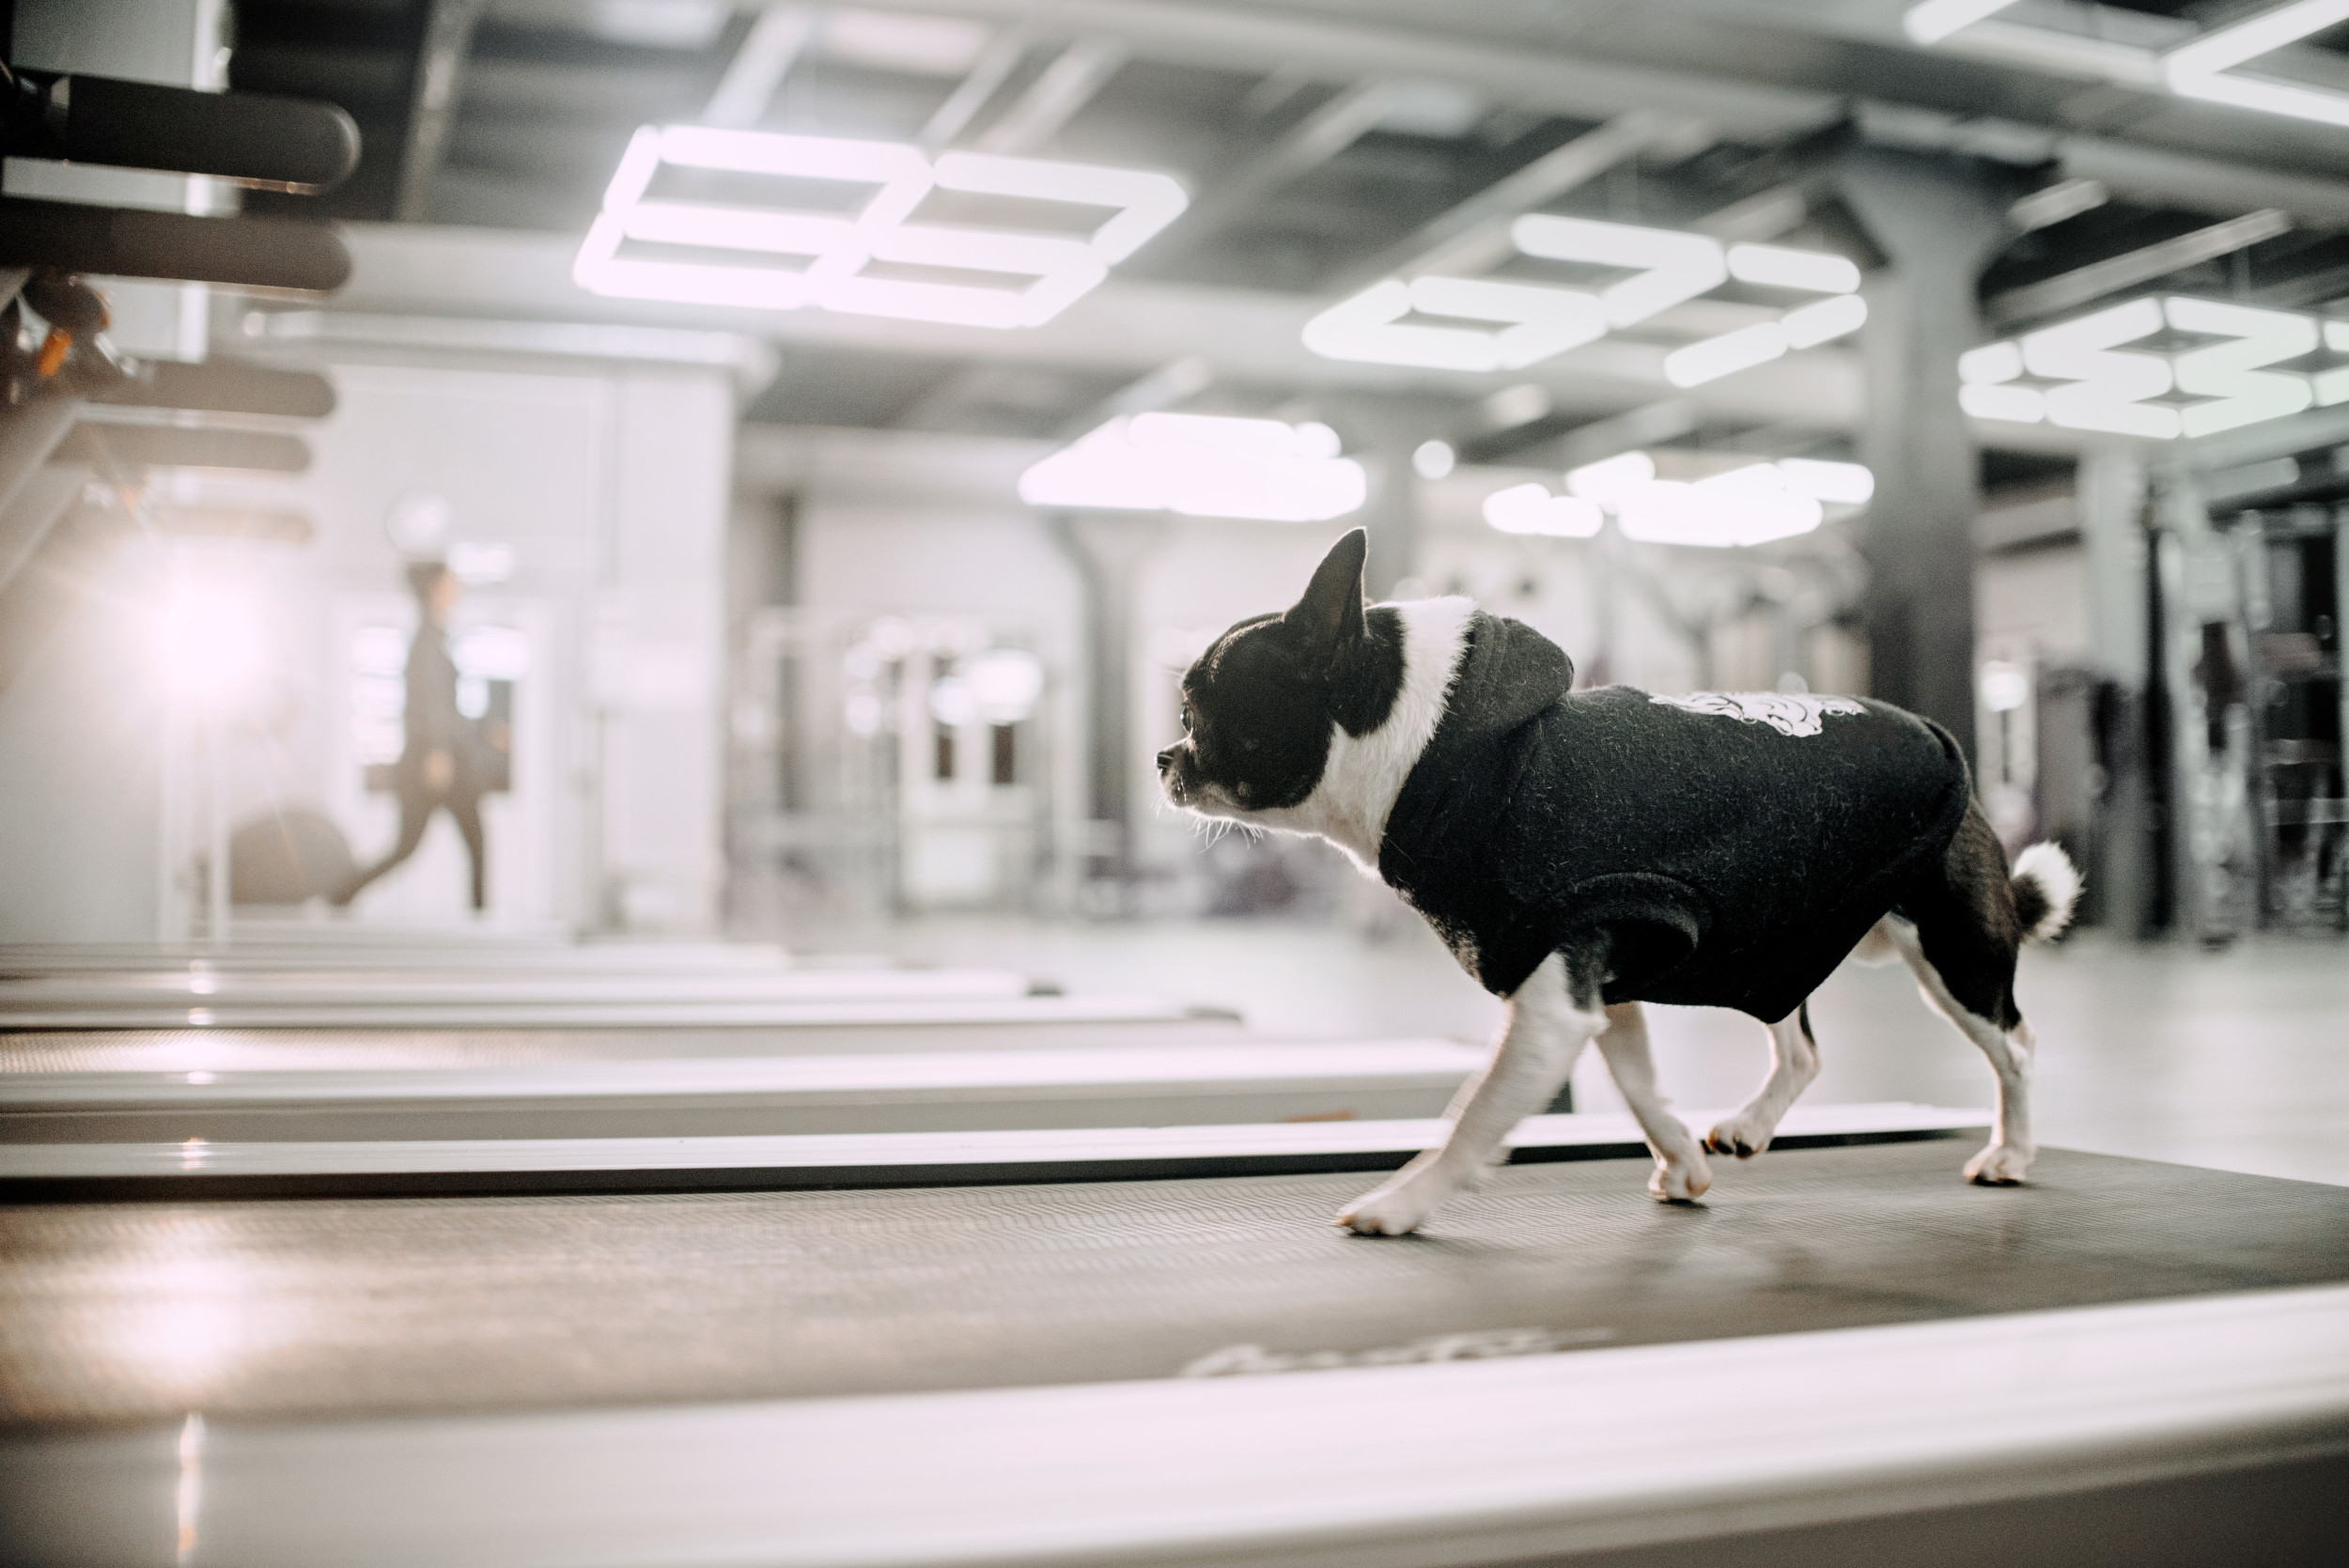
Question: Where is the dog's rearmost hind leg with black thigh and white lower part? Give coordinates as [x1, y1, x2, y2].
[1887, 805, 2039, 1186]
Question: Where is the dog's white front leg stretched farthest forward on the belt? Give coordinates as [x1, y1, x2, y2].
[1337, 953, 1607, 1237]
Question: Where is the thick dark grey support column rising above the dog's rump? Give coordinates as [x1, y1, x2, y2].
[1837, 147, 2011, 761]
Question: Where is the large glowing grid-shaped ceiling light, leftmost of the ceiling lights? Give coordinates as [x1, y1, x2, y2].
[571, 124, 1189, 329]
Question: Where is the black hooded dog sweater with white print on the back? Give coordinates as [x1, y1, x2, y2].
[1379, 611, 1973, 1023]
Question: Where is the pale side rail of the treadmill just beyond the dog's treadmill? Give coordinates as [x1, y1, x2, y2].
[0, 1040, 1489, 1145]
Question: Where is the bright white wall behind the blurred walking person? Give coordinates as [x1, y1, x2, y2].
[0, 362, 733, 941]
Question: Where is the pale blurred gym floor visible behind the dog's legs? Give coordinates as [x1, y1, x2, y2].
[864, 918, 2349, 1186]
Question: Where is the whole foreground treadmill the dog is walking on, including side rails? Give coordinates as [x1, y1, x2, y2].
[0, 1089, 2349, 1568]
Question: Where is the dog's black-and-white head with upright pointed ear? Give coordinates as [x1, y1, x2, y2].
[1159, 528, 1403, 819]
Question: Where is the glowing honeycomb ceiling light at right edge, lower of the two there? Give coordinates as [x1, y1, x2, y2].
[1957, 296, 2349, 442]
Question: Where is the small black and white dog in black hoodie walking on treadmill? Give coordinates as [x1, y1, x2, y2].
[1159, 531, 2079, 1234]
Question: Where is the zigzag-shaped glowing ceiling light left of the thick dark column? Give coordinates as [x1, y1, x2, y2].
[1304, 213, 1868, 385]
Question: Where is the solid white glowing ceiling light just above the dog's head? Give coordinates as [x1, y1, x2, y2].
[1019, 413, 1370, 523]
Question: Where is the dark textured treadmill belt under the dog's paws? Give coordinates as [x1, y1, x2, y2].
[0, 1141, 2349, 1427]
